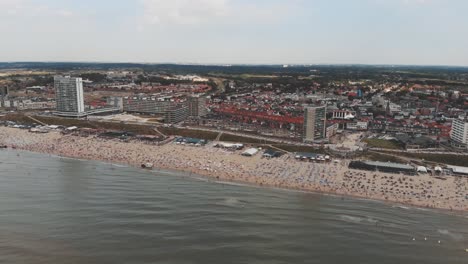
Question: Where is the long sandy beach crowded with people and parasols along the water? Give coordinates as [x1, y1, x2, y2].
[0, 127, 468, 211]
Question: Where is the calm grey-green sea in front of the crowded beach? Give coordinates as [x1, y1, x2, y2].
[0, 150, 468, 264]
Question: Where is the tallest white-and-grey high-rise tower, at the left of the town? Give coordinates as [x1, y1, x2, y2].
[54, 76, 85, 115]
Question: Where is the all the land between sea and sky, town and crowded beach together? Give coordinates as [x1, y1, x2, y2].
[0, 65, 468, 211]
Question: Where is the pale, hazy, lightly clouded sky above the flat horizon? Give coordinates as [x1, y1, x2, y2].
[0, 0, 468, 66]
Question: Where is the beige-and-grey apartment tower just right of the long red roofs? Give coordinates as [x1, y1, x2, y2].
[304, 106, 327, 142]
